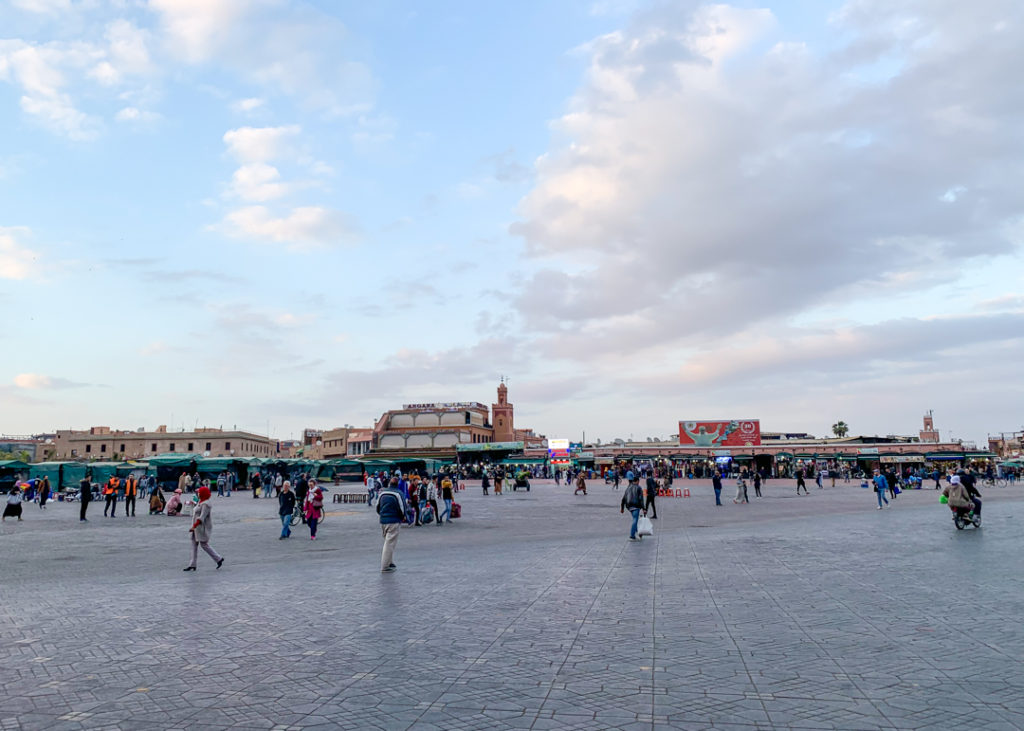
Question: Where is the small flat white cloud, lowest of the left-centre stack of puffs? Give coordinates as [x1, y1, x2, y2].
[221, 206, 355, 250]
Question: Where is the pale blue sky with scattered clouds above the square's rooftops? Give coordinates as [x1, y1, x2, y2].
[0, 0, 1024, 443]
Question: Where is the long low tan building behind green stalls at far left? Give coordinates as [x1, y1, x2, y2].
[49, 426, 278, 461]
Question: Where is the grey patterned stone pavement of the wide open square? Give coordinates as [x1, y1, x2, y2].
[0, 481, 1024, 729]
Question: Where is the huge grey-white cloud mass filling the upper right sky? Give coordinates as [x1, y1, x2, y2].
[511, 0, 1024, 355]
